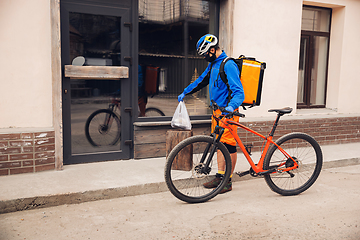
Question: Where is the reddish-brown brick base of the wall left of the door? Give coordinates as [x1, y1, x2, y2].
[0, 131, 55, 175]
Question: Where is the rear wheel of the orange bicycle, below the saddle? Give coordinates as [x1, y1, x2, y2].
[264, 133, 323, 196]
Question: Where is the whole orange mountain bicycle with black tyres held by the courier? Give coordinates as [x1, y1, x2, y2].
[165, 102, 323, 203]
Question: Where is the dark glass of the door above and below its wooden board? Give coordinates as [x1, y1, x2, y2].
[69, 12, 121, 154]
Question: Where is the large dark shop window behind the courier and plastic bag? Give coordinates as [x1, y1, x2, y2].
[138, 0, 218, 117]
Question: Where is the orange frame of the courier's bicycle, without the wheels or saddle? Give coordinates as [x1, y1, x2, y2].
[213, 113, 299, 175]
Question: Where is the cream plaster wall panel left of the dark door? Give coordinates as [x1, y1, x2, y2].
[0, 0, 52, 128]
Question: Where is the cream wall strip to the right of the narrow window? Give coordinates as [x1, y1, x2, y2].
[304, 0, 360, 113]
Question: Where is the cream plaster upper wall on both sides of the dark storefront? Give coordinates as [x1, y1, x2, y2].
[0, 0, 360, 125]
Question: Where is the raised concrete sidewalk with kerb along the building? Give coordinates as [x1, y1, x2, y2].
[0, 143, 360, 213]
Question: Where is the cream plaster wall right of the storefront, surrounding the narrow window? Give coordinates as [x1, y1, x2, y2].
[220, 0, 360, 117]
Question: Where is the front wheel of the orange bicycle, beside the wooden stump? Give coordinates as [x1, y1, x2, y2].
[165, 136, 231, 203]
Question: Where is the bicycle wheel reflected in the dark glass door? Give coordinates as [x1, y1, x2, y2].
[85, 109, 121, 147]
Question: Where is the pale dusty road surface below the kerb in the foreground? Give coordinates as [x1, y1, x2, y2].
[0, 165, 360, 240]
